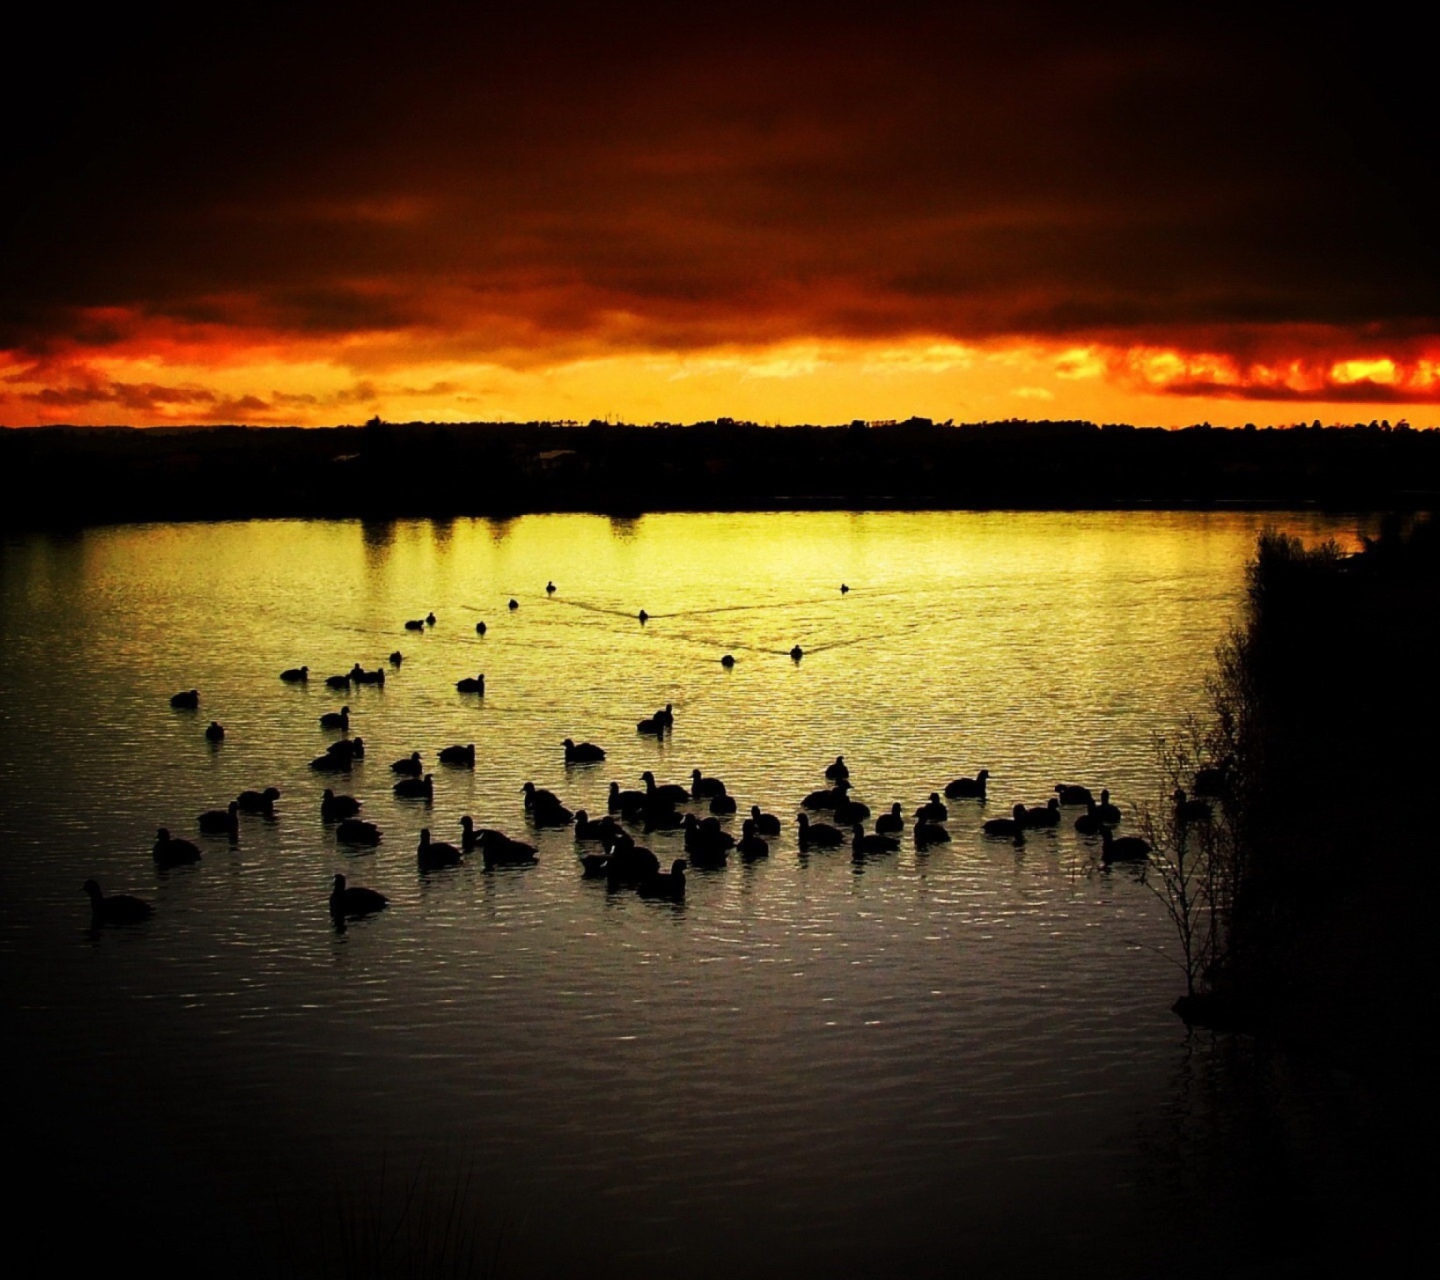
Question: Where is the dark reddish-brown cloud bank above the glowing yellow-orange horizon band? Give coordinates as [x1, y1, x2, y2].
[0, 4, 1440, 368]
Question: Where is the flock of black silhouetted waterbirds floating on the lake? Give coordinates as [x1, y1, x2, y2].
[84, 583, 1225, 927]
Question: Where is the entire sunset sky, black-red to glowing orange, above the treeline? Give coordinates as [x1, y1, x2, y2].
[0, 0, 1440, 426]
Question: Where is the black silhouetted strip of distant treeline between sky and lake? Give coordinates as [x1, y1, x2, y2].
[0, 419, 1440, 527]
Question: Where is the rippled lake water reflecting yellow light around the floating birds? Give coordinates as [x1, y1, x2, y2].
[0, 513, 1381, 1277]
